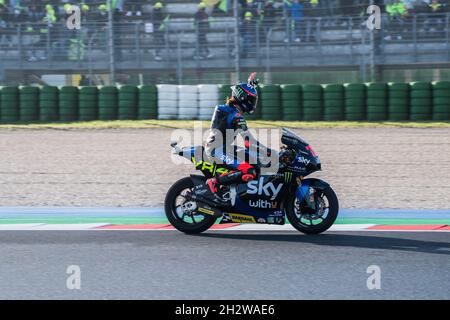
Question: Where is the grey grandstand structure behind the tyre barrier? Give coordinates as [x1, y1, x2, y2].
[0, 0, 450, 84]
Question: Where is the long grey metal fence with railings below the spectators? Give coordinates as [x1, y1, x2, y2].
[0, 13, 450, 83]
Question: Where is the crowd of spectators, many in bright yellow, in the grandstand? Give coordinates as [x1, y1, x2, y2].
[0, 0, 450, 61]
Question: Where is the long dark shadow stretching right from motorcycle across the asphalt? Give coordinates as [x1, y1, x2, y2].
[196, 233, 450, 255]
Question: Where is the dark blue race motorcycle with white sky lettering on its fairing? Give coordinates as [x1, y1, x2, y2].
[164, 128, 339, 234]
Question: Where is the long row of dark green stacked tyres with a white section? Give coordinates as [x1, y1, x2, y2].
[0, 81, 450, 123]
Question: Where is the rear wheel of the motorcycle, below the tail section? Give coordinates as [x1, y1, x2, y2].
[164, 177, 217, 234]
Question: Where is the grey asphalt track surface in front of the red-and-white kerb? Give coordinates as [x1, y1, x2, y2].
[0, 231, 450, 299]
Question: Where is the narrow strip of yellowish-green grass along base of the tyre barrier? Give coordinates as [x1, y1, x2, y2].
[0, 120, 450, 130]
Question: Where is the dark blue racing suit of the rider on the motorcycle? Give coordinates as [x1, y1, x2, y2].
[205, 102, 270, 193]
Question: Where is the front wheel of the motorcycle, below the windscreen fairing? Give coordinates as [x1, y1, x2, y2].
[286, 186, 339, 234]
